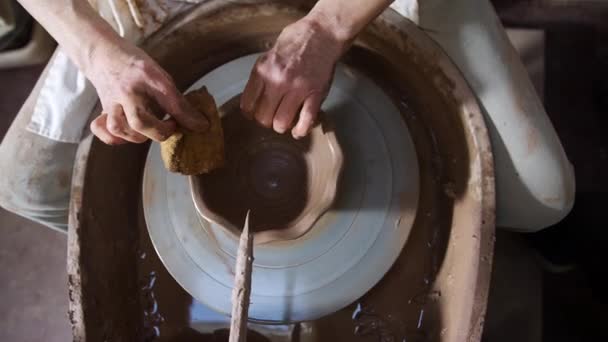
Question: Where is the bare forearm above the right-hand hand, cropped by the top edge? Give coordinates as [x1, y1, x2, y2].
[309, 0, 393, 45]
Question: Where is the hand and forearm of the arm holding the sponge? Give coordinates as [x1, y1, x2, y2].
[19, 0, 208, 144]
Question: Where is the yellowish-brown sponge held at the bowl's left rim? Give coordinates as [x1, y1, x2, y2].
[160, 87, 225, 175]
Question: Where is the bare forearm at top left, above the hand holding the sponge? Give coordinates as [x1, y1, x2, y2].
[18, 0, 123, 74]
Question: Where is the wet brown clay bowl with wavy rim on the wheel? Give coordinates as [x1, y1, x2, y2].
[190, 95, 343, 244]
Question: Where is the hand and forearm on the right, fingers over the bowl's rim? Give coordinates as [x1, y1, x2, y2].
[241, 0, 391, 138]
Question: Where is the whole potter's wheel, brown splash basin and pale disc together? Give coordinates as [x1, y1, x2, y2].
[69, 0, 494, 341]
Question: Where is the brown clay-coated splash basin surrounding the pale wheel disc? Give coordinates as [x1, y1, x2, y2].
[69, 1, 494, 341]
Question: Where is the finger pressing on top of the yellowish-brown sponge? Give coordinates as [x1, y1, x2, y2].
[148, 81, 209, 132]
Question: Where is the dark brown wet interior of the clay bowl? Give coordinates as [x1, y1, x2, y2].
[197, 98, 310, 232]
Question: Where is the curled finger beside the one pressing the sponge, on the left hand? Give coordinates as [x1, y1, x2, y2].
[123, 95, 177, 141]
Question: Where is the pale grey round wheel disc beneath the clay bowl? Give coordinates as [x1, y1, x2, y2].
[143, 55, 419, 322]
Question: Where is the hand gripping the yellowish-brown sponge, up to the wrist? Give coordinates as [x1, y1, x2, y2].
[85, 41, 209, 145]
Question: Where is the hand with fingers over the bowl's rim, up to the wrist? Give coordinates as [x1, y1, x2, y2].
[241, 15, 346, 138]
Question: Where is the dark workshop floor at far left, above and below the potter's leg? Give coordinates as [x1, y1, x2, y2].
[0, 67, 71, 342]
